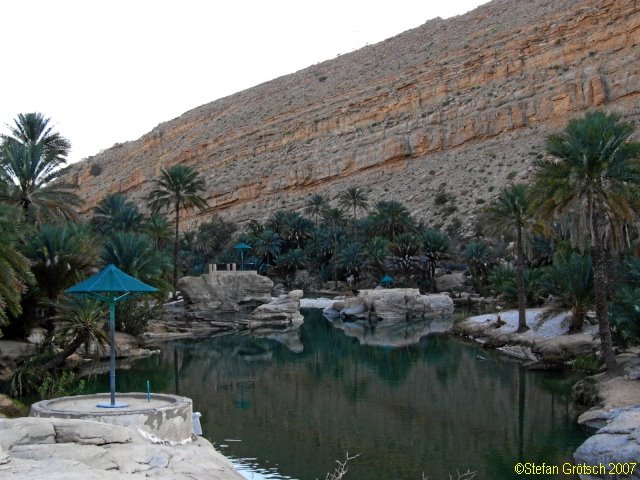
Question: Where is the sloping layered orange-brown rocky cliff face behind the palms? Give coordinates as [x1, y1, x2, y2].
[67, 0, 640, 232]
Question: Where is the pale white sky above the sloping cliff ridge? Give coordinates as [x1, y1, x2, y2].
[0, 0, 487, 163]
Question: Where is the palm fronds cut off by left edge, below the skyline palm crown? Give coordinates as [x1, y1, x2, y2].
[0, 204, 31, 325]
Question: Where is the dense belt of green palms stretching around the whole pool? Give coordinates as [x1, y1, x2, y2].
[0, 112, 640, 392]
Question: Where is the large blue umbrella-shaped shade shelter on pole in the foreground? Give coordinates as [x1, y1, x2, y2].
[64, 265, 158, 408]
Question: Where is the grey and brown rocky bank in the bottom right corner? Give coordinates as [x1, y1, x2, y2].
[574, 352, 640, 480]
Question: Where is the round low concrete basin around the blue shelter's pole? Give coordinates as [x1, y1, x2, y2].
[29, 393, 193, 442]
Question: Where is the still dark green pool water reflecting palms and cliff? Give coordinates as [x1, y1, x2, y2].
[87, 310, 586, 480]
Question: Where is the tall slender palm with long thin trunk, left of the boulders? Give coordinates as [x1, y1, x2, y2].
[149, 165, 207, 298]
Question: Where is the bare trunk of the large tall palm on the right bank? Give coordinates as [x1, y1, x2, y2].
[590, 206, 618, 371]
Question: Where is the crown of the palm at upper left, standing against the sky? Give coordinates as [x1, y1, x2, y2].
[0, 113, 79, 223]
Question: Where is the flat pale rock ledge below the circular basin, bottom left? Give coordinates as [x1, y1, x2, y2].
[0, 417, 243, 480]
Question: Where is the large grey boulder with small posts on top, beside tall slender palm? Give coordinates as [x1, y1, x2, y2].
[178, 271, 273, 319]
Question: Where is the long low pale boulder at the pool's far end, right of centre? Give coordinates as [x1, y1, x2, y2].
[325, 288, 453, 323]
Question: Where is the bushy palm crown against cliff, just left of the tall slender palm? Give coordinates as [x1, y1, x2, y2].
[91, 193, 144, 235]
